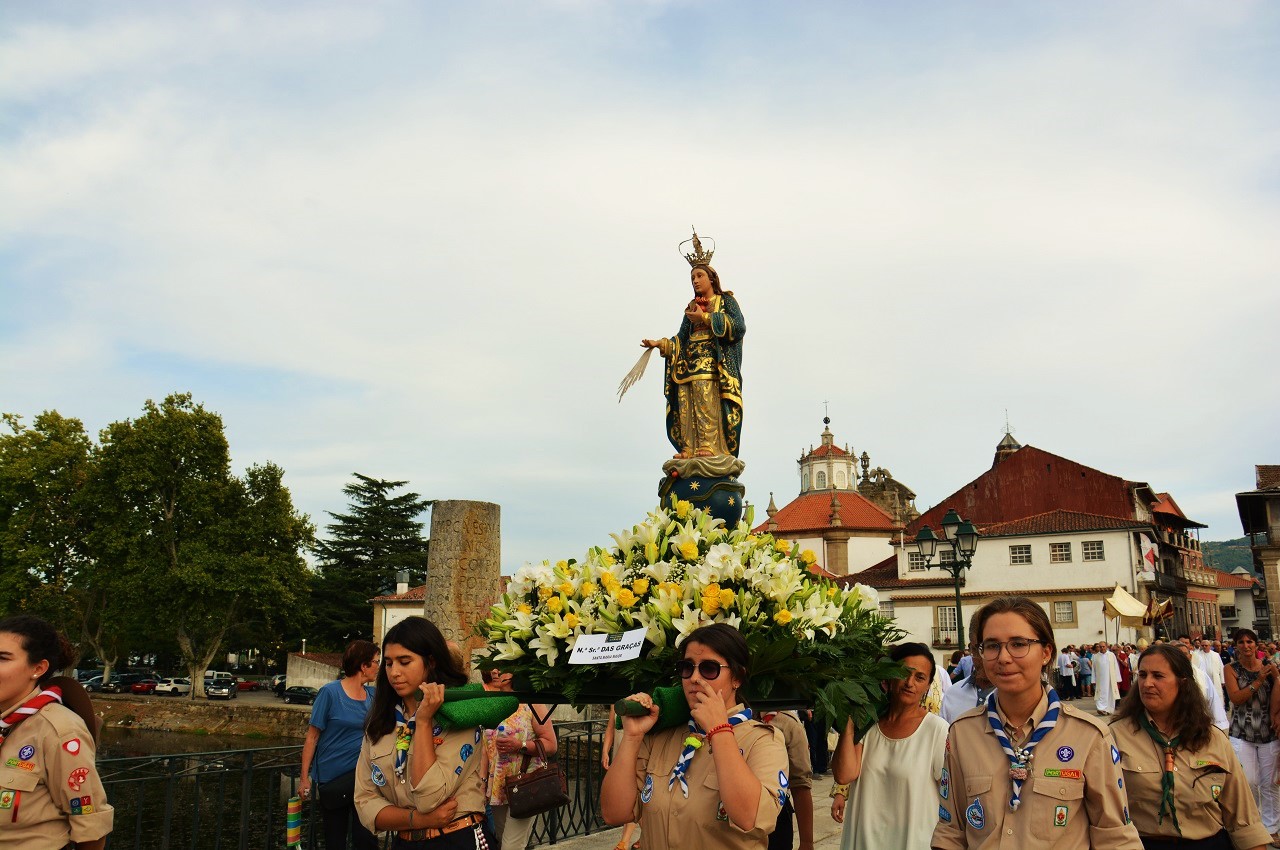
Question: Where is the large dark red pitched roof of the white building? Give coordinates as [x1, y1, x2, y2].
[906, 445, 1156, 536]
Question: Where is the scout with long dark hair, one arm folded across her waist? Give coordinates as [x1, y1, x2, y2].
[356, 617, 494, 850]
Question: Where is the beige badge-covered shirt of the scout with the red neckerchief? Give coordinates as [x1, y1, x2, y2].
[0, 691, 114, 850]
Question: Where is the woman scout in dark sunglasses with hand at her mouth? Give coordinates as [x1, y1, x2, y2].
[600, 623, 788, 850]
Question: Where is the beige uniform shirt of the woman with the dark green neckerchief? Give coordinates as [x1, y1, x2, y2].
[1111, 719, 1271, 847]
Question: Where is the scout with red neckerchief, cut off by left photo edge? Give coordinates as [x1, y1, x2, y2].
[0, 616, 114, 850]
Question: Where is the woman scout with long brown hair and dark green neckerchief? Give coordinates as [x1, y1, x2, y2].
[1111, 644, 1271, 850]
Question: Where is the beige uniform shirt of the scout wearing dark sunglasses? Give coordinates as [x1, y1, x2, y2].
[635, 708, 788, 850]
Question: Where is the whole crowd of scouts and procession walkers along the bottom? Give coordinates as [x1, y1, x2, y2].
[10, 606, 1280, 850]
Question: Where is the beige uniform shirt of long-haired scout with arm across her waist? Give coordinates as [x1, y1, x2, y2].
[355, 725, 485, 832]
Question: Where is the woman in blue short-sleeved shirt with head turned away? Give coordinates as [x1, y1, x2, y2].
[298, 640, 379, 850]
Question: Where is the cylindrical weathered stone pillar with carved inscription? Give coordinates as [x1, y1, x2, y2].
[422, 499, 502, 648]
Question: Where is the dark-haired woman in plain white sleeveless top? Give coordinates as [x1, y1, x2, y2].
[831, 644, 952, 850]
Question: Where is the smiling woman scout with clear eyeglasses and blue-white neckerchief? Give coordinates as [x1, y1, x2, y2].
[932, 597, 1142, 850]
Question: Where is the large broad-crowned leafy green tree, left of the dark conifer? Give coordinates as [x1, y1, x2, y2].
[96, 394, 312, 695]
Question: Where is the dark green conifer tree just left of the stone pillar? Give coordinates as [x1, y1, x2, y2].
[311, 472, 431, 649]
